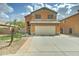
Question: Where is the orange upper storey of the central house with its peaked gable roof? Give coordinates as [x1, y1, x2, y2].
[25, 7, 57, 20]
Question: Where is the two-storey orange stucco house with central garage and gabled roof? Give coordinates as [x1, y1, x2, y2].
[25, 7, 60, 35]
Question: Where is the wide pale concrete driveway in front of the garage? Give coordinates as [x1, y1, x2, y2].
[15, 35, 79, 56]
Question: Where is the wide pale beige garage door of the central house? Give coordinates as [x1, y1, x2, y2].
[35, 26, 55, 35]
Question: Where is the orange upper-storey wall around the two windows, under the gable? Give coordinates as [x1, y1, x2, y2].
[32, 10, 56, 20]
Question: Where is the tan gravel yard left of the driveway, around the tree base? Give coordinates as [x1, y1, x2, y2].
[0, 37, 27, 55]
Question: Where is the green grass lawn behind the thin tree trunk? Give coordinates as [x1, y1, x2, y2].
[0, 33, 22, 40]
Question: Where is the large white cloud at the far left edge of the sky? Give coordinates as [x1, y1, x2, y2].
[0, 3, 14, 22]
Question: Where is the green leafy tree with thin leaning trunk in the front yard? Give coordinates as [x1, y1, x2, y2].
[6, 19, 25, 46]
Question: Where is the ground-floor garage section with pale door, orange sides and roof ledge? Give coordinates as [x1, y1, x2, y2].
[30, 21, 59, 35]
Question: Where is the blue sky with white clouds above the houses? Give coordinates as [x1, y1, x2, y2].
[0, 3, 79, 21]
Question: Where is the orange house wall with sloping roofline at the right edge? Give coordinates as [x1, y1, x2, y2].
[60, 13, 79, 35]
